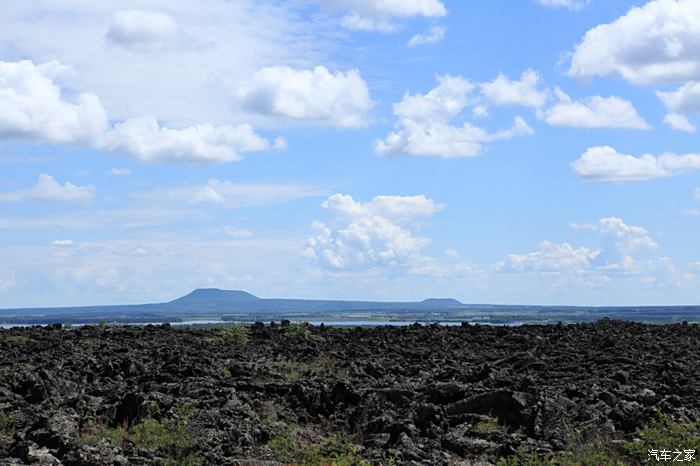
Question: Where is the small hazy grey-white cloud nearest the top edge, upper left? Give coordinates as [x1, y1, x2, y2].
[107, 9, 196, 52]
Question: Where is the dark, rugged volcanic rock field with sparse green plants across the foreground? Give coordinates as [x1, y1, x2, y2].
[0, 320, 700, 466]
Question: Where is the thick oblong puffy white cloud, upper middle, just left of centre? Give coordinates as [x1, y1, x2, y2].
[236, 66, 373, 128]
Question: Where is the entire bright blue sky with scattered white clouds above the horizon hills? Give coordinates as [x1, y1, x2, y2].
[0, 0, 700, 307]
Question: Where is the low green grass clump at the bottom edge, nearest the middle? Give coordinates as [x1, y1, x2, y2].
[267, 434, 371, 466]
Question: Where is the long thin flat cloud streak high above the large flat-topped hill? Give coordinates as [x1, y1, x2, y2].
[132, 179, 325, 208]
